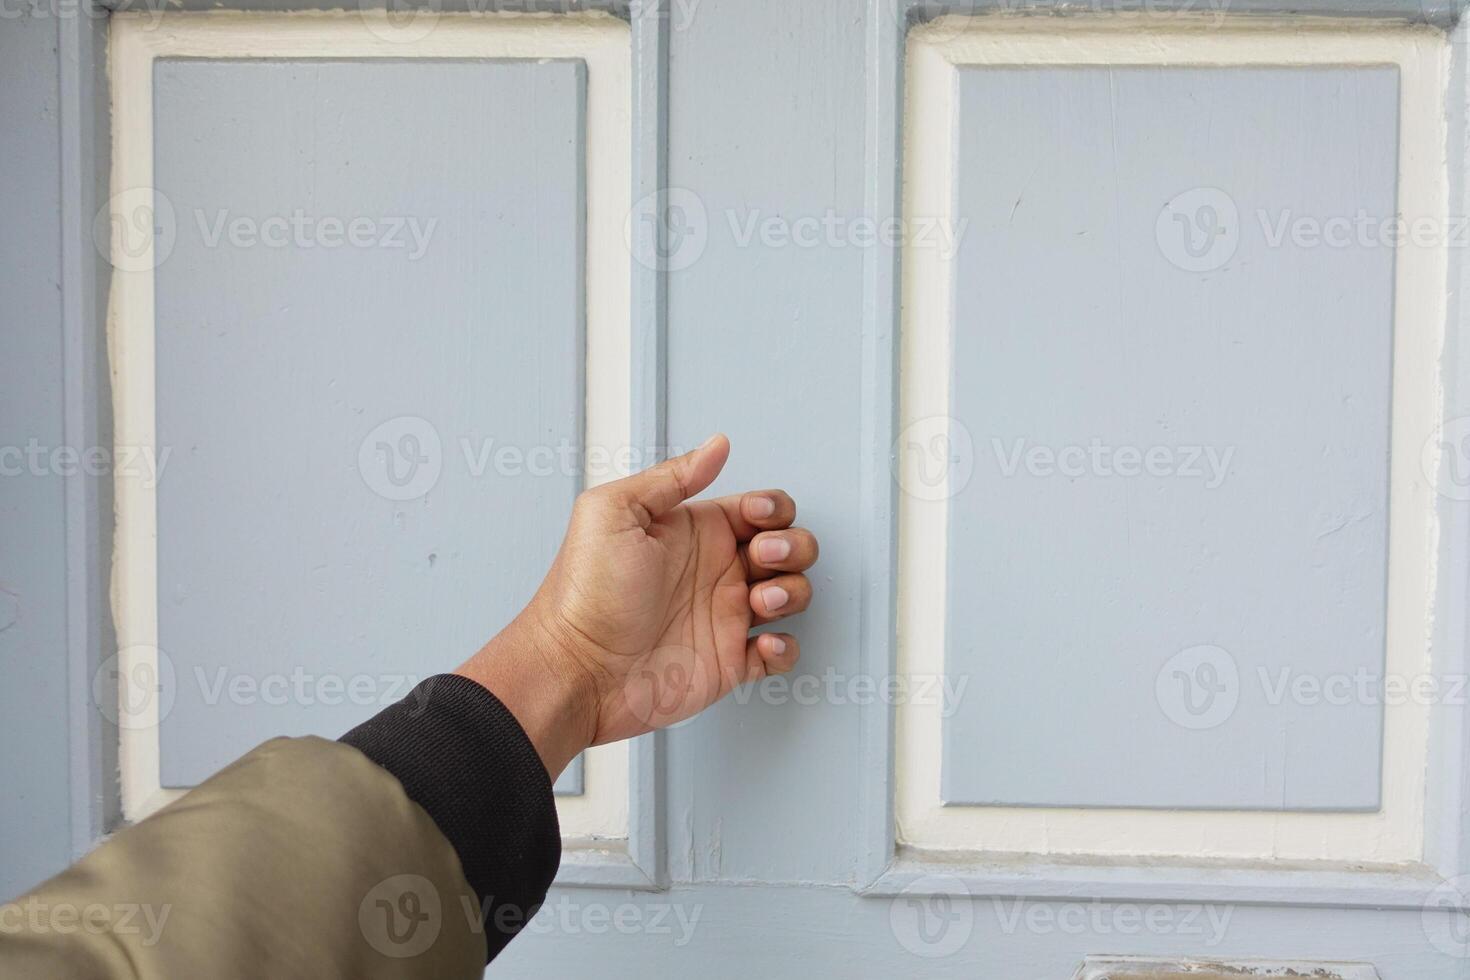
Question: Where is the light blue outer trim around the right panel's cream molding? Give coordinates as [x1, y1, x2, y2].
[856, 0, 1470, 908]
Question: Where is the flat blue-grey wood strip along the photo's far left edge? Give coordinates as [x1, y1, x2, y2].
[0, 11, 79, 893]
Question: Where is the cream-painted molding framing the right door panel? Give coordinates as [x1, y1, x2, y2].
[894, 15, 1449, 867]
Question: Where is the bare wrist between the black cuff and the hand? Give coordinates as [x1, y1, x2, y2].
[454, 610, 597, 782]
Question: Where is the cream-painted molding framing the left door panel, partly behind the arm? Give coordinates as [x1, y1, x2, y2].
[107, 10, 637, 846]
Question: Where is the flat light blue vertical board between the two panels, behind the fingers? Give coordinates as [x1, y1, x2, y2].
[667, 0, 872, 882]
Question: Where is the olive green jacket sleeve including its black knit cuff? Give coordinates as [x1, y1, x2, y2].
[0, 674, 560, 980]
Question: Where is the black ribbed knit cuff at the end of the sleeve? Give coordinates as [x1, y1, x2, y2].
[340, 674, 562, 962]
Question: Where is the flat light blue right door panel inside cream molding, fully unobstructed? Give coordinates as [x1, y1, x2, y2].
[944, 68, 1399, 810]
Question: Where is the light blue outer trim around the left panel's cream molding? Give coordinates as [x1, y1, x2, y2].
[83, 0, 669, 890]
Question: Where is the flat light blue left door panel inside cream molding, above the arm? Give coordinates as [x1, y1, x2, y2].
[154, 60, 584, 786]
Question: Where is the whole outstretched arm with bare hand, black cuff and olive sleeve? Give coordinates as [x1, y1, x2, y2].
[0, 436, 817, 980]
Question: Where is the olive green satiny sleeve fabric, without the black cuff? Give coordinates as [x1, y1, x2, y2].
[0, 738, 487, 980]
